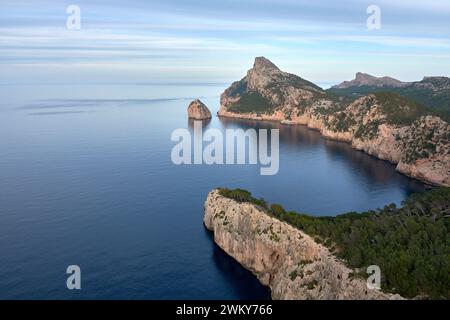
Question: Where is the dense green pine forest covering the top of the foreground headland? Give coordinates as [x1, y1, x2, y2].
[220, 188, 450, 299]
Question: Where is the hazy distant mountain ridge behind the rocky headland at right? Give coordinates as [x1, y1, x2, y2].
[327, 73, 450, 120]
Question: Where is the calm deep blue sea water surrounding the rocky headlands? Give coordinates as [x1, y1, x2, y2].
[0, 84, 424, 299]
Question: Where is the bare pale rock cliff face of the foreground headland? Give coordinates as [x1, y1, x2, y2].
[204, 190, 401, 300]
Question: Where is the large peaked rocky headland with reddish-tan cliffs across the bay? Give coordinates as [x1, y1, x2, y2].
[218, 58, 450, 186]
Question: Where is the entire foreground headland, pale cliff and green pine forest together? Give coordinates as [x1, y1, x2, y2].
[203, 188, 450, 300]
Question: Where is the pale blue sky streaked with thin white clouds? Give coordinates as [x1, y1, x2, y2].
[0, 0, 450, 85]
